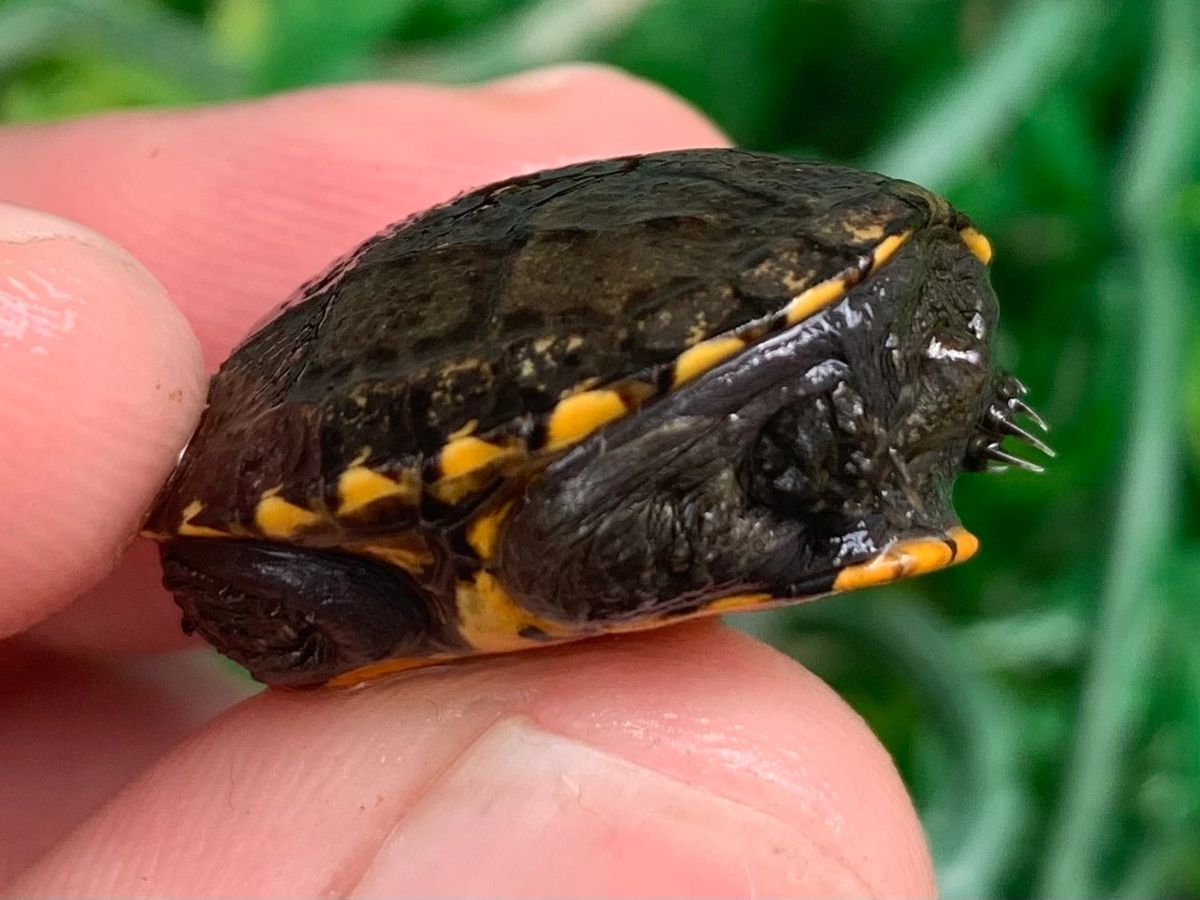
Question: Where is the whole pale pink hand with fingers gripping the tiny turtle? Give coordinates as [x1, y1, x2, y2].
[0, 70, 934, 896]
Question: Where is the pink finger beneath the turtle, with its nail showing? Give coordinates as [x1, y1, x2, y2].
[10, 626, 934, 896]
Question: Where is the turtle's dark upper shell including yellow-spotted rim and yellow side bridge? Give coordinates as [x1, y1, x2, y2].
[146, 150, 990, 686]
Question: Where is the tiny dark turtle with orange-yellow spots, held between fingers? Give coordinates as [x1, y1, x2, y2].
[146, 150, 1051, 684]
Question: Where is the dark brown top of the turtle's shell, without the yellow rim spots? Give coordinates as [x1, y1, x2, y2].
[148, 150, 967, 544]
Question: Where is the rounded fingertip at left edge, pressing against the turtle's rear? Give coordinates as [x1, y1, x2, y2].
[0, 204, 204, 637]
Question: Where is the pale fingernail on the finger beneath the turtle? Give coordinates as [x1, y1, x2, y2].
[355, 719, 870, 896]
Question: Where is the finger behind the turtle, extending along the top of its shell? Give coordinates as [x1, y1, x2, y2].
[0, 67, 724, 650]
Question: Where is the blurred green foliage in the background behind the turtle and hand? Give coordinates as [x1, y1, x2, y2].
[0, 0, 1200, 896]
